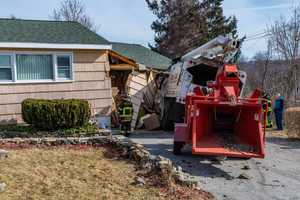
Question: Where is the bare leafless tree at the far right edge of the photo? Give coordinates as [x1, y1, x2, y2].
[268, 6, 300, 101]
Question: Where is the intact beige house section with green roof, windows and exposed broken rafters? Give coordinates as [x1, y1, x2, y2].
[0, 19, 170, 124]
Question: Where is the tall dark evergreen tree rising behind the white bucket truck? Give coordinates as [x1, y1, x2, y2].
[146, 0, 237, 58]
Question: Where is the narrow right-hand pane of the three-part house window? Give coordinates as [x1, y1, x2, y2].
[57, 56, 71, 79]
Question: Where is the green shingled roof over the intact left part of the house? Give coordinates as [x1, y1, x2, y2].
[0, 19, 109, 45]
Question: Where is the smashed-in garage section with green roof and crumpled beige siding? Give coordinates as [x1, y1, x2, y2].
[112, 42, 171, 129]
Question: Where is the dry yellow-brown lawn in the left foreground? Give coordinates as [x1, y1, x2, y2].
[0, 148, 164, 200]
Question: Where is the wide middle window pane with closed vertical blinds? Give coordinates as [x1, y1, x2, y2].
[16, 54, 53, 80]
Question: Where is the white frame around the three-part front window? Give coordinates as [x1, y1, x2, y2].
[0, 51, 74, 84]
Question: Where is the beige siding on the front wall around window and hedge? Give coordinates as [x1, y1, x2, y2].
[0, 49, 112, 123]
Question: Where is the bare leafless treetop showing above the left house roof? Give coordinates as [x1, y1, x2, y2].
[51, 0, 98, 32]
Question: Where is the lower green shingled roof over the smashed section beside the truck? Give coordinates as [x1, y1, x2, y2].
[112, 42, 171, 70]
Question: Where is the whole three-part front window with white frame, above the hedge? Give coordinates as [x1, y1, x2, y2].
[0, 52, 73, 83]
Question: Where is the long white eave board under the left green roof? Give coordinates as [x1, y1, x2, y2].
[0, 42, 112, 50]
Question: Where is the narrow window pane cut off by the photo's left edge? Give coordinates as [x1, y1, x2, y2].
[0, 54, 12, 81]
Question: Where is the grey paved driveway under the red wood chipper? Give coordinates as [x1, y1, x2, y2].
[130, 131, 300, 200]
